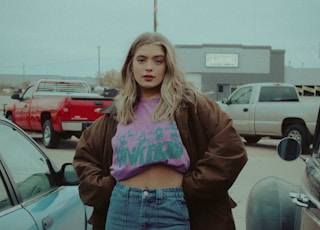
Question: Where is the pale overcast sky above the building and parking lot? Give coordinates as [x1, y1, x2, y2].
[0, 0, 320, 76]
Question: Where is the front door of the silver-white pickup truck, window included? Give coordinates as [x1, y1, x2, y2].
[225, 86, 254, 134]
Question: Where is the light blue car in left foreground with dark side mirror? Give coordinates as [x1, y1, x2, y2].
[0, 117, 92, 230]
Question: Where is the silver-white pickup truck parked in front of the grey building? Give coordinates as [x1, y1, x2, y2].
[217, 83, 320, 154]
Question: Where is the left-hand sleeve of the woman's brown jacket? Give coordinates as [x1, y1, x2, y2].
[73, 115, 115, 209]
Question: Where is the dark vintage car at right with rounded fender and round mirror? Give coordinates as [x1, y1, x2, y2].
[246, 106, 320, 230]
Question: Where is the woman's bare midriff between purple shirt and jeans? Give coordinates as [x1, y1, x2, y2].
[120, 164, 183, 189]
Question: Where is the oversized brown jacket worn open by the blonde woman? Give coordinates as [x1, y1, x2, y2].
[73, 96, 247, 230]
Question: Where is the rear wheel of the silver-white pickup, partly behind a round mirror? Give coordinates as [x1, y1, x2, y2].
[284, 125, 310, 154]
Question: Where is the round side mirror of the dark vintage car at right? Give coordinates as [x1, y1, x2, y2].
[277, 137, 301, 161]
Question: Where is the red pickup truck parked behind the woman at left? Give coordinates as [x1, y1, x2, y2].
[4, 79, 113, 148]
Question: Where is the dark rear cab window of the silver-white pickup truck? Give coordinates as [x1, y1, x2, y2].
[259, 86, 299, 102]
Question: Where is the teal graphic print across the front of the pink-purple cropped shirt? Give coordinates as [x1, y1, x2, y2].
[111, 120, 190, 180]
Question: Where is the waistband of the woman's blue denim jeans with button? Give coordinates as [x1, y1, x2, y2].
[114, 182, 184, 199]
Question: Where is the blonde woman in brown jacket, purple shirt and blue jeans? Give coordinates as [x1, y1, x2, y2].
[73, 33, 247, 230]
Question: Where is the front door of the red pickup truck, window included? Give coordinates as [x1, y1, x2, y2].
[13, 86, 33, 130]
